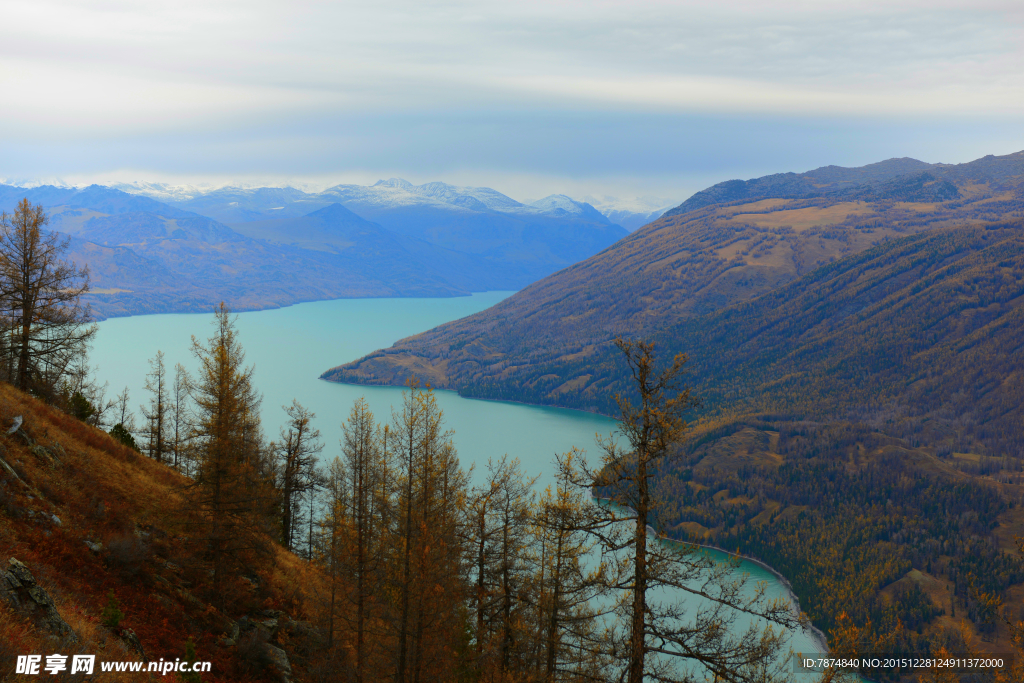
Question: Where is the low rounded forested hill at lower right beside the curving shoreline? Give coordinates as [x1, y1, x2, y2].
[638, 417, 1024, 680]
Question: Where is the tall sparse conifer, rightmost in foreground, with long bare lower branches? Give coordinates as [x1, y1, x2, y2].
[574, 339, 799, 683]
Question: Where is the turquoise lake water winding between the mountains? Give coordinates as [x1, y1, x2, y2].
[90, 292, 822, 671]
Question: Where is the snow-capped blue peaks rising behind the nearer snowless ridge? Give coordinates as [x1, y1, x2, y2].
[94, 178, 627, 291]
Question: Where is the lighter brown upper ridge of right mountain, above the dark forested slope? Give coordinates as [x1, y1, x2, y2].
[324, 153, 1024, 409]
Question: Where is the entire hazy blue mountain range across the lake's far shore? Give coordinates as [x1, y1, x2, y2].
[0, 180, 627, 316]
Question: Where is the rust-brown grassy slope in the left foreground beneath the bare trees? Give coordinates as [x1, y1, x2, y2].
[0, 384, 322, 681]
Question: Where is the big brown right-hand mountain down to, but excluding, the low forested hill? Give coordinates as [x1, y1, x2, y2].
[324, 153, 1024, 453]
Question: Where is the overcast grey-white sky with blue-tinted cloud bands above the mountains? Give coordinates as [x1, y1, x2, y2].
[0, 0, 1024, 203]
